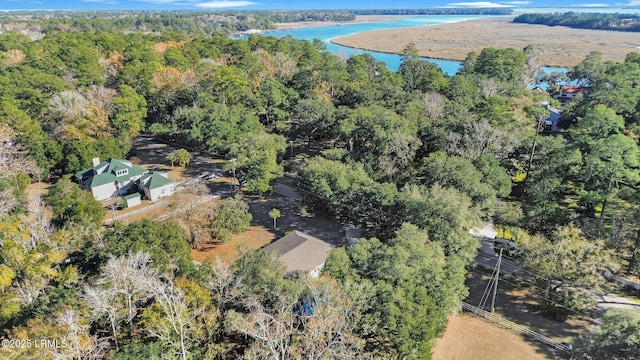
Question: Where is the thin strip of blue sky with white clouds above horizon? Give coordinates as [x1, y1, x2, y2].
[0, 0, 640, 12]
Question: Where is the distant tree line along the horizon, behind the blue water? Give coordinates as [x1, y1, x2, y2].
[0, 9, 511, 37]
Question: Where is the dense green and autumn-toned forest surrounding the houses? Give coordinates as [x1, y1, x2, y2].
[0, 9, 640, 359]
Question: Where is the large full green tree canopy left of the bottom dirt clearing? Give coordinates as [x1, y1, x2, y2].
[325, 223, 467, 359]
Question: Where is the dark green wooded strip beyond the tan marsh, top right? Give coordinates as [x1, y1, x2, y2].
[513, 12, 640, 32]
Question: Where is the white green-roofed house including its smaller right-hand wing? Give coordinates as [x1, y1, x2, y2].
[75, 158, 175, 206]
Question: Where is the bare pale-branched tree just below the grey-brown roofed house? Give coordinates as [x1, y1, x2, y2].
[229, 278, 364, 360]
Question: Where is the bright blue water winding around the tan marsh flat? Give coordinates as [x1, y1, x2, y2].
[264, 15, 567, 76]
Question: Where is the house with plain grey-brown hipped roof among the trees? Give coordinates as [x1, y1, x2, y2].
[262, 230, 333, 278]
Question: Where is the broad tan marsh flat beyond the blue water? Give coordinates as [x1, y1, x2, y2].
[332, 16, 640, 67]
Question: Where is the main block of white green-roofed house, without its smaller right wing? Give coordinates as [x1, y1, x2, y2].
[76, 158, 146, 200]
